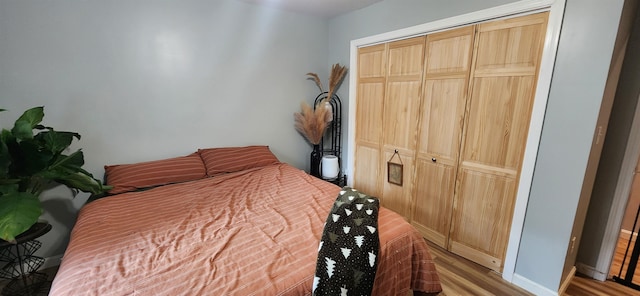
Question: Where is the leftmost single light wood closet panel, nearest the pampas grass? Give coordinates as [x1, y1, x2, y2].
[353, 44, 387, 197]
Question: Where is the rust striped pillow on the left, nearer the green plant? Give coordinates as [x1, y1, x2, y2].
[104, 153, 207, 194]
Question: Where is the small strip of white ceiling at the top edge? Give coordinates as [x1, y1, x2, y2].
[238, 0, 382, 18]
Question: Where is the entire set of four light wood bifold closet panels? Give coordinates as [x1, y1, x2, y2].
[353, 12, 548, 272]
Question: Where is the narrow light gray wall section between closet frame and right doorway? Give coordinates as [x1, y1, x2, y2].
[516, 0, 624, 291]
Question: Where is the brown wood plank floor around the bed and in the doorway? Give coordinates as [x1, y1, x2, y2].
[5, 243, 640, 296]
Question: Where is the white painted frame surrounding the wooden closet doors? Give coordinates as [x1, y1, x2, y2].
[346, 0, 566, 282]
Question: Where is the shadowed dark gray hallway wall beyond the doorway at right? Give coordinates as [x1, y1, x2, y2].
[577, 1, 640, 273]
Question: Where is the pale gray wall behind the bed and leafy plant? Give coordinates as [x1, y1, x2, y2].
[0, 0, 329, 256]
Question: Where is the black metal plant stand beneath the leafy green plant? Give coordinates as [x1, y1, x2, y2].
[0, 222, 51, 295]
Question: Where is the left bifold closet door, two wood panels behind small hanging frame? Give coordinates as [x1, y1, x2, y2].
[354, 36, 425, 220]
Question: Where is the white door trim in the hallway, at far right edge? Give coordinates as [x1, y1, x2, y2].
[595, 92, 640, 280]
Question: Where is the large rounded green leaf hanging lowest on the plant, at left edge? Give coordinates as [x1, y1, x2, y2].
[0, 192, 42, 242]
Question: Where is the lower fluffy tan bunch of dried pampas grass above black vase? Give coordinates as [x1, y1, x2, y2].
[293, 99, 333, 145]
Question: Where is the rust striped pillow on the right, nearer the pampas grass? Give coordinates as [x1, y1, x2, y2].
[198, 146, 280, 177]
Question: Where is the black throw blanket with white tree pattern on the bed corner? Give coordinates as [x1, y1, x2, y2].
[313, 187, 380, 296]
